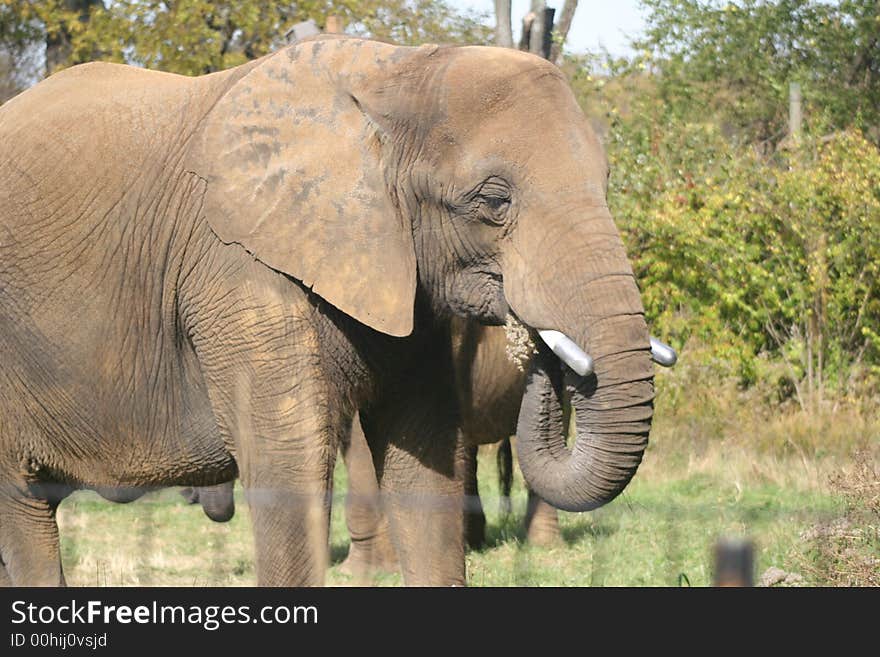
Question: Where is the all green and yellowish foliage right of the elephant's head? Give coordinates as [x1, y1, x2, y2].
[568, 0, 880, 410]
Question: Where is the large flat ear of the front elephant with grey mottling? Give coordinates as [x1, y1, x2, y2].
[187, 39, 416, 336]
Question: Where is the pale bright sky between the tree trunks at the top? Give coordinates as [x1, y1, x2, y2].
[450, 0, 644, 55]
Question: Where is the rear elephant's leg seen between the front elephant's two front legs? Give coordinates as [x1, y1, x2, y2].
[340, 417, 398, 581]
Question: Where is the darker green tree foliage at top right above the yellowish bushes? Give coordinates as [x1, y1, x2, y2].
[635, 0, 880, 144]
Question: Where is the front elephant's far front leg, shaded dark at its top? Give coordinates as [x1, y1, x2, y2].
[361, 386, 465, 586]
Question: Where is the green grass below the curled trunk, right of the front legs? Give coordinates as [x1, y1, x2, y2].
[458, 444, 840, 586]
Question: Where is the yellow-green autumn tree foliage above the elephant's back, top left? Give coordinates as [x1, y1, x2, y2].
[0, 0, 491, 84]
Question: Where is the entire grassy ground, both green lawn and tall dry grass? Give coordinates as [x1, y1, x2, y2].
[58, 368, 880, 586]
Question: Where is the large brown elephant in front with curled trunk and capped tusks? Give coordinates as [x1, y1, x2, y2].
[0, 37, 654, 586]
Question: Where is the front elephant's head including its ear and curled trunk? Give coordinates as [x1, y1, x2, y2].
[189, 38, 654, 511]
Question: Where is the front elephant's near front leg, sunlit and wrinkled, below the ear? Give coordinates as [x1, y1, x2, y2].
[181, 266, 352, 586]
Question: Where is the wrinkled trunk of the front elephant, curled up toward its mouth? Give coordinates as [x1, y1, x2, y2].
[505, 211, 654, 511]
